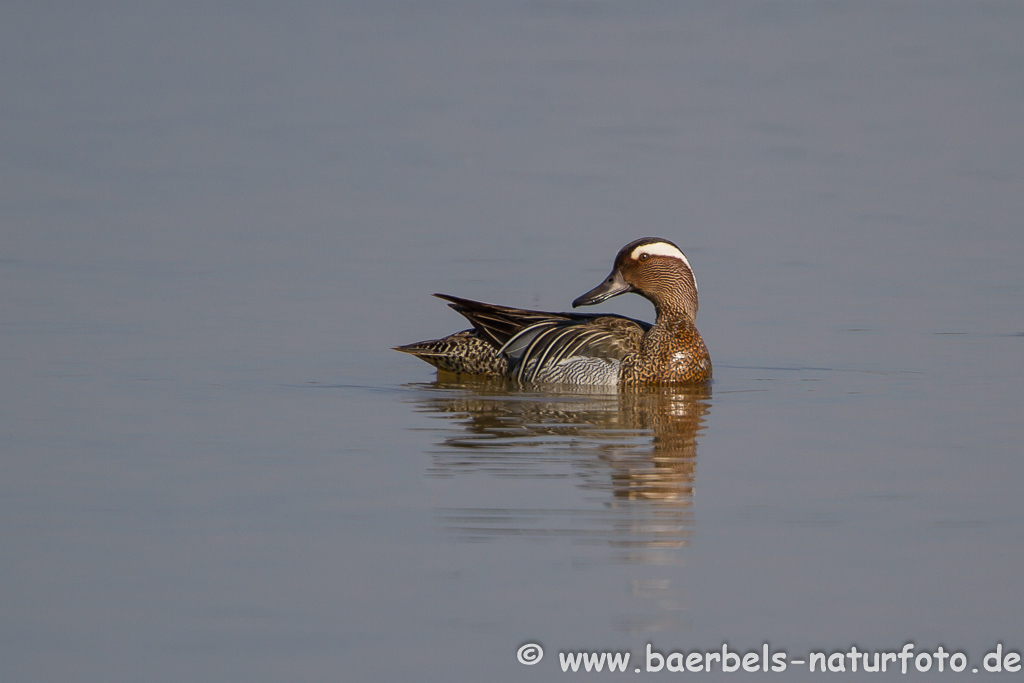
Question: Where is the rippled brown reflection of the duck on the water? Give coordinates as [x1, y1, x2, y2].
[407, 382, 711, 548]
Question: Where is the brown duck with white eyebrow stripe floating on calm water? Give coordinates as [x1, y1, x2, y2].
[394, 238, 712, 387]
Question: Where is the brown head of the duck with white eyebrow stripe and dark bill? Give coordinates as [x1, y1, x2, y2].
[572, 238, 697, 319]
